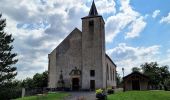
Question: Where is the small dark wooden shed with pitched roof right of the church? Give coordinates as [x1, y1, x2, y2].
[123, 72, 149, 91]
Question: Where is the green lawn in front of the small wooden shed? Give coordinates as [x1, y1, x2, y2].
[108, 91, 170, 100]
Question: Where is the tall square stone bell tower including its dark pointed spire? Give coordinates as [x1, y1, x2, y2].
[81, 0, 106, 90]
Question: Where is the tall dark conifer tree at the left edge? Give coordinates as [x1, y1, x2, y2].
[0, 14, 18, 85]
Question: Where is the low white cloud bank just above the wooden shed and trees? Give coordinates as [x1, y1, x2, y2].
[107, 43, 160, 74]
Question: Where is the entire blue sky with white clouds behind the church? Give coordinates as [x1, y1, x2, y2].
[0, 0, 170, 79]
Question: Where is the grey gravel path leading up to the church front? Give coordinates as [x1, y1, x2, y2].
[65, 91, 96, 100]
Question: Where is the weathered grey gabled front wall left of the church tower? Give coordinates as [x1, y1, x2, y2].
[48, 28, 82, 88]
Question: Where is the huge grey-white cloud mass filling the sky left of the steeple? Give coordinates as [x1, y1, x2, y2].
[0, 0, 89, 79]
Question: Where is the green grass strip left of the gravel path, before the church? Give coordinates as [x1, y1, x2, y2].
[16, 92, 69, 100]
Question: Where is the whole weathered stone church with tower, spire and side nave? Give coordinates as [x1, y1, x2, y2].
[48, 1, 116, 90]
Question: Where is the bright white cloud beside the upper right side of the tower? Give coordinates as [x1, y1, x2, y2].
[106, 0, 146, 42]
